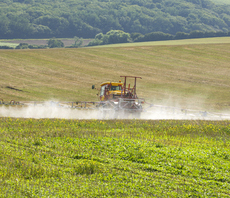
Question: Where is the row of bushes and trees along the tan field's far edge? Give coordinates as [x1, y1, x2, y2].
[0, 30, 230, 49]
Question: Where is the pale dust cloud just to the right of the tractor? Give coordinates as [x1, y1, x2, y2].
[144, 96, 230, 120]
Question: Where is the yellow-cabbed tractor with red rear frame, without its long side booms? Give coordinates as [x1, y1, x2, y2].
[92, 76, 144, 118]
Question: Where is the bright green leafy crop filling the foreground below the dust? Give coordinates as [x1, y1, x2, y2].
[0, 118, 230, 197]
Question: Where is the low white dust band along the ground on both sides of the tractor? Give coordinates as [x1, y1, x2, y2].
[0, 102, 230, 120]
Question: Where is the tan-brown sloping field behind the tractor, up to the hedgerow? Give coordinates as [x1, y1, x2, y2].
[0, 37, 230, 109]
